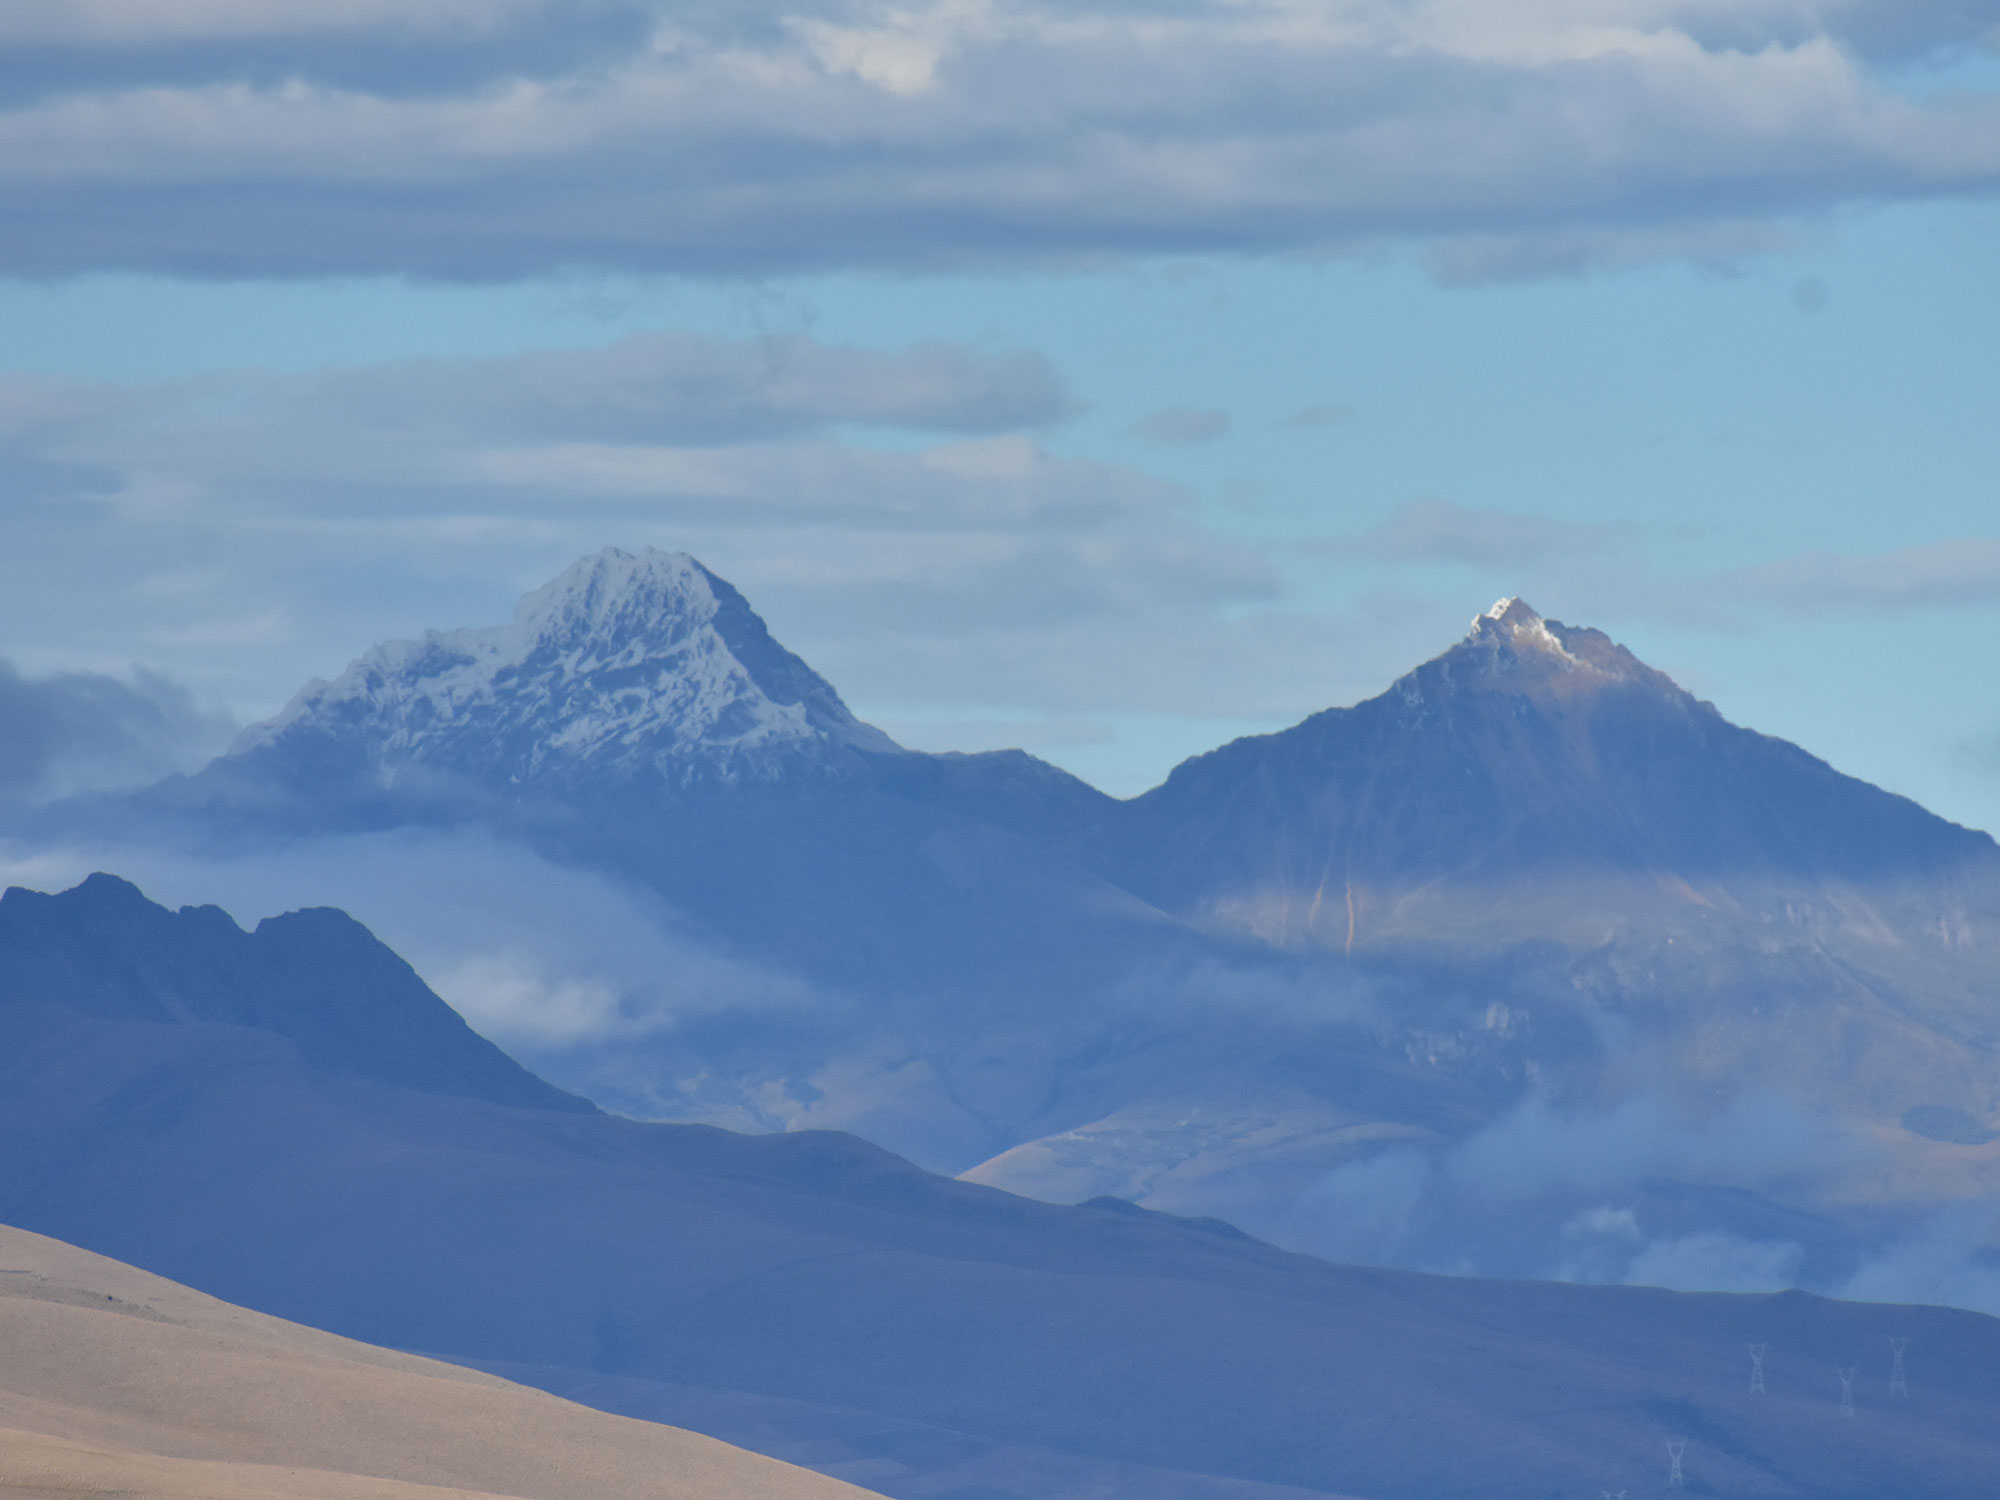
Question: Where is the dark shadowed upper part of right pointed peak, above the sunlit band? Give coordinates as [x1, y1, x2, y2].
[1118, 600, 2000, 916]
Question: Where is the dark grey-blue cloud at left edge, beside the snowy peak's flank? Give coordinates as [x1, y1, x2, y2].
[0, 660, 236, 802]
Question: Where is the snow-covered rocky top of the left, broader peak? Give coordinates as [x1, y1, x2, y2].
[232, 548, 898, 784]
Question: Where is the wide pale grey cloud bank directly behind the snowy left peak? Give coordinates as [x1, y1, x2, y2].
[0, 334, 1328, 736]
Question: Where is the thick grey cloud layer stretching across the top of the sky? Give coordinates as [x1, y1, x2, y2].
[0, 0, 2000, 278]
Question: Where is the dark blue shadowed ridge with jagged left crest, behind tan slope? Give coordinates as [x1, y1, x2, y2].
[0, 878, 2000, 1500]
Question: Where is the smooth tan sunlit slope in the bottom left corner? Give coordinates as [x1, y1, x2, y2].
[0, 1226, 870, 1500]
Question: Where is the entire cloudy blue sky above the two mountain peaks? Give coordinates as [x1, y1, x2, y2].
[0, 0, 2000, 830]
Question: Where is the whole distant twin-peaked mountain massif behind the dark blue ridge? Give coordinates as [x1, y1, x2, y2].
[30, 552, 2000, 1306]
